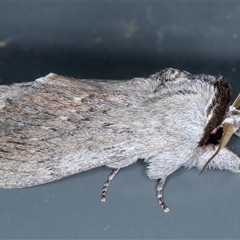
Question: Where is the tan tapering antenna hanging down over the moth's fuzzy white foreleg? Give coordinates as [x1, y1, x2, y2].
[199, 122, 234, 175]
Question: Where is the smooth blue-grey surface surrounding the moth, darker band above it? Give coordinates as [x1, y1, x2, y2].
[0, 2, 240, 239]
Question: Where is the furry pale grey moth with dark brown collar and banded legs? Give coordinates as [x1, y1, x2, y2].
[0, 68, 240, 212]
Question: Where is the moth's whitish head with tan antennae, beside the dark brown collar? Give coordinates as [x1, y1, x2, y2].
[200, 93, 240, 174]
